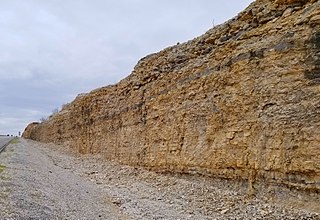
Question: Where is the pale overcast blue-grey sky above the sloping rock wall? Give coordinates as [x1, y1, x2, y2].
[0, 0, 253, 135]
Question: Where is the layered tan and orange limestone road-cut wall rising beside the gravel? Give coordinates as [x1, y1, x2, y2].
[24, 0, 320, 190]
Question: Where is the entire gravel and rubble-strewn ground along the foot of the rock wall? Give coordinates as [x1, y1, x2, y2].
[0, 139, 320, 220]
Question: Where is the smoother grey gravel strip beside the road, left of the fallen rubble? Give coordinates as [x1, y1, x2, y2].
[0, 140, 127, 219]
